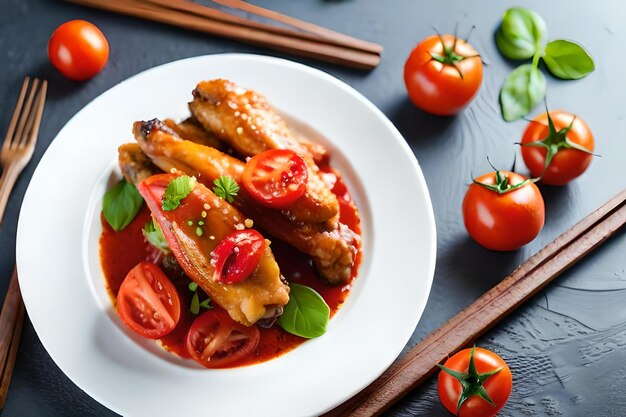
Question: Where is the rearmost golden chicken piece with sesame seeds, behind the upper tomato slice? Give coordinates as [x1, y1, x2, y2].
[189, 79, 339, 226]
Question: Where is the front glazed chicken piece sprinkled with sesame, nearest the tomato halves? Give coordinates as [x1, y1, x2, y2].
[136, 172, 289, 326]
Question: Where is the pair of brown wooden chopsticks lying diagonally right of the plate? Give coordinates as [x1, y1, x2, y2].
[324, 189, 626, 417]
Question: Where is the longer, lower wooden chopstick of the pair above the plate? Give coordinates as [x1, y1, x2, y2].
[66, 0, 380, 69]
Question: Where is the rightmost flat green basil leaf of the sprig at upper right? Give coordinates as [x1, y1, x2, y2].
[543, 39, 595, 80]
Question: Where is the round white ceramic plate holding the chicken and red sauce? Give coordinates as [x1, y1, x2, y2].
[17, 54, 436, 417]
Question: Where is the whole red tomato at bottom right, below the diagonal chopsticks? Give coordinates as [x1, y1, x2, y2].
[437, 348, 513, 417]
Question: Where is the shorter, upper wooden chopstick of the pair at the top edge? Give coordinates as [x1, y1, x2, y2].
[211, 0, 383, 55]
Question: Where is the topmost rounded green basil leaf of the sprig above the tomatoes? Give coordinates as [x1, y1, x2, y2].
[496, 7, 547, 59]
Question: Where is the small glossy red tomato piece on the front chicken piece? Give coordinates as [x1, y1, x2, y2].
[211, 229, 265, 284]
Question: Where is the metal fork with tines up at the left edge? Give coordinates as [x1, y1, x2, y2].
[0, 77, 48, 223]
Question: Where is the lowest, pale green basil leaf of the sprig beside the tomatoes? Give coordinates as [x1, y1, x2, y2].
[500, 64, 546, 122]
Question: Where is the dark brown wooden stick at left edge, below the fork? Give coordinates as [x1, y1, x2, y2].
[0, 268, 24, 409]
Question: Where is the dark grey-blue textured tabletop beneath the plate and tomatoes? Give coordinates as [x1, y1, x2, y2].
[0, 0, 626, 417]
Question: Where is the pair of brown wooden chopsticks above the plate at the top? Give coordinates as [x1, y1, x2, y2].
[66, 0, 383, 70]
